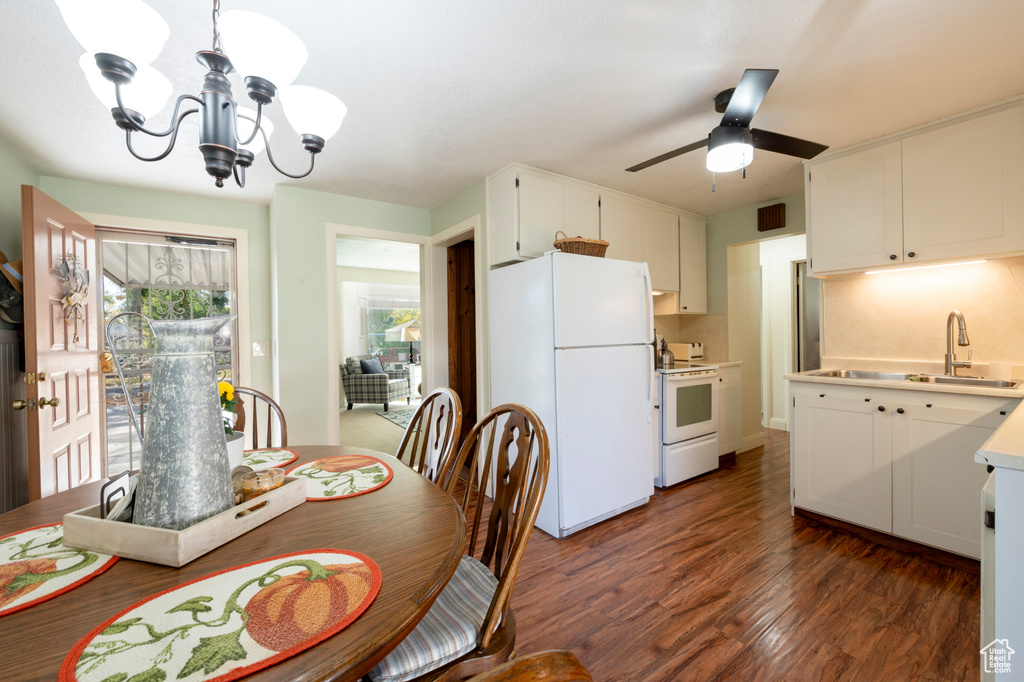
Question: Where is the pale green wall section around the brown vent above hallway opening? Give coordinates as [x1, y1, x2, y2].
[708, 193, 807, 315]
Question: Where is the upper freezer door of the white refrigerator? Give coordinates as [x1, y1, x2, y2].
[551, 253, 654, 348]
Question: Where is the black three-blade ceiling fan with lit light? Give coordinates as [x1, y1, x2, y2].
[626, 69, 828, 173]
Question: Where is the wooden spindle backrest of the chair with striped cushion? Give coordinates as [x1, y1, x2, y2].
[438, 404, 551, 648]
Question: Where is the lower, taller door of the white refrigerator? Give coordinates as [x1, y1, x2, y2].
[555, 346, 654, 529]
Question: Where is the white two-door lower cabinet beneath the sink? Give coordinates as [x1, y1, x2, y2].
[791, 382, 1020, 558]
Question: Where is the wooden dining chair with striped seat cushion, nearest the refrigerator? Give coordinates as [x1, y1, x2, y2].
[369, 404, 550, 682]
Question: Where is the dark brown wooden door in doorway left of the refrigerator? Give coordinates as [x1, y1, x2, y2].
[447, 240, 477, 441]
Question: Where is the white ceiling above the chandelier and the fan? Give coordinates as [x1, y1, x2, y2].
[0, 0, 1024, 214]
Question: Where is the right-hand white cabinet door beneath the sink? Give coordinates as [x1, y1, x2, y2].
[892, 396, 1017, 559]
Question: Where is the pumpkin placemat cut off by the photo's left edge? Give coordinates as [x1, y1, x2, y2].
[0, 523, 118, 616]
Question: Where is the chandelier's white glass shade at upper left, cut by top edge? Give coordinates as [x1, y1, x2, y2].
[55, 0, 171, 69]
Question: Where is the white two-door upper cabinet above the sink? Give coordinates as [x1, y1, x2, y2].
[804, 101, 1024, 274]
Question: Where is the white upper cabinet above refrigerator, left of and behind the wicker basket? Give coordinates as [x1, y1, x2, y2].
[487, 166, 601, 263]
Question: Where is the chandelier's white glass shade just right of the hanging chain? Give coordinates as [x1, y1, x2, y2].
[218, 9, 309, 91]
